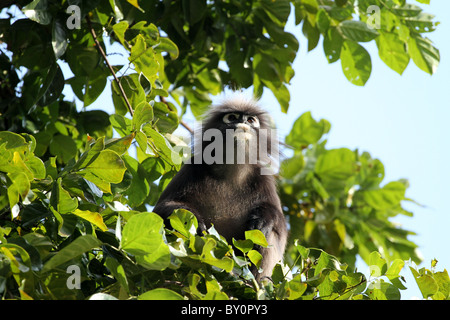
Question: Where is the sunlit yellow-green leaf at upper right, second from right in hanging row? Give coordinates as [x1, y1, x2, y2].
[377, 33, 410, 74]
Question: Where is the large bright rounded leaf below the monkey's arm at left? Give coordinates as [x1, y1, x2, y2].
[120, 212, 170, 270]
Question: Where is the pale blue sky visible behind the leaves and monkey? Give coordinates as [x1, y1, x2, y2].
[2, 0, 450, 299]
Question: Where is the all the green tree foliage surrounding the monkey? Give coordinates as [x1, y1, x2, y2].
[0, 0, 442, 299]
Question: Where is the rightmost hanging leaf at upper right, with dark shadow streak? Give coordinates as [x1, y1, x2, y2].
[408, 34, 440, 74]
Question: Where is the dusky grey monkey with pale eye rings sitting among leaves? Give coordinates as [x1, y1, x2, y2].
[153, 99, 288, 282]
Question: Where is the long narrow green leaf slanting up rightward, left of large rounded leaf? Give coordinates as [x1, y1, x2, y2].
[42, 234, 102, 272]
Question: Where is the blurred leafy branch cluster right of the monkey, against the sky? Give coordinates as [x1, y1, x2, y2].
[279, 112, 420, 267]
